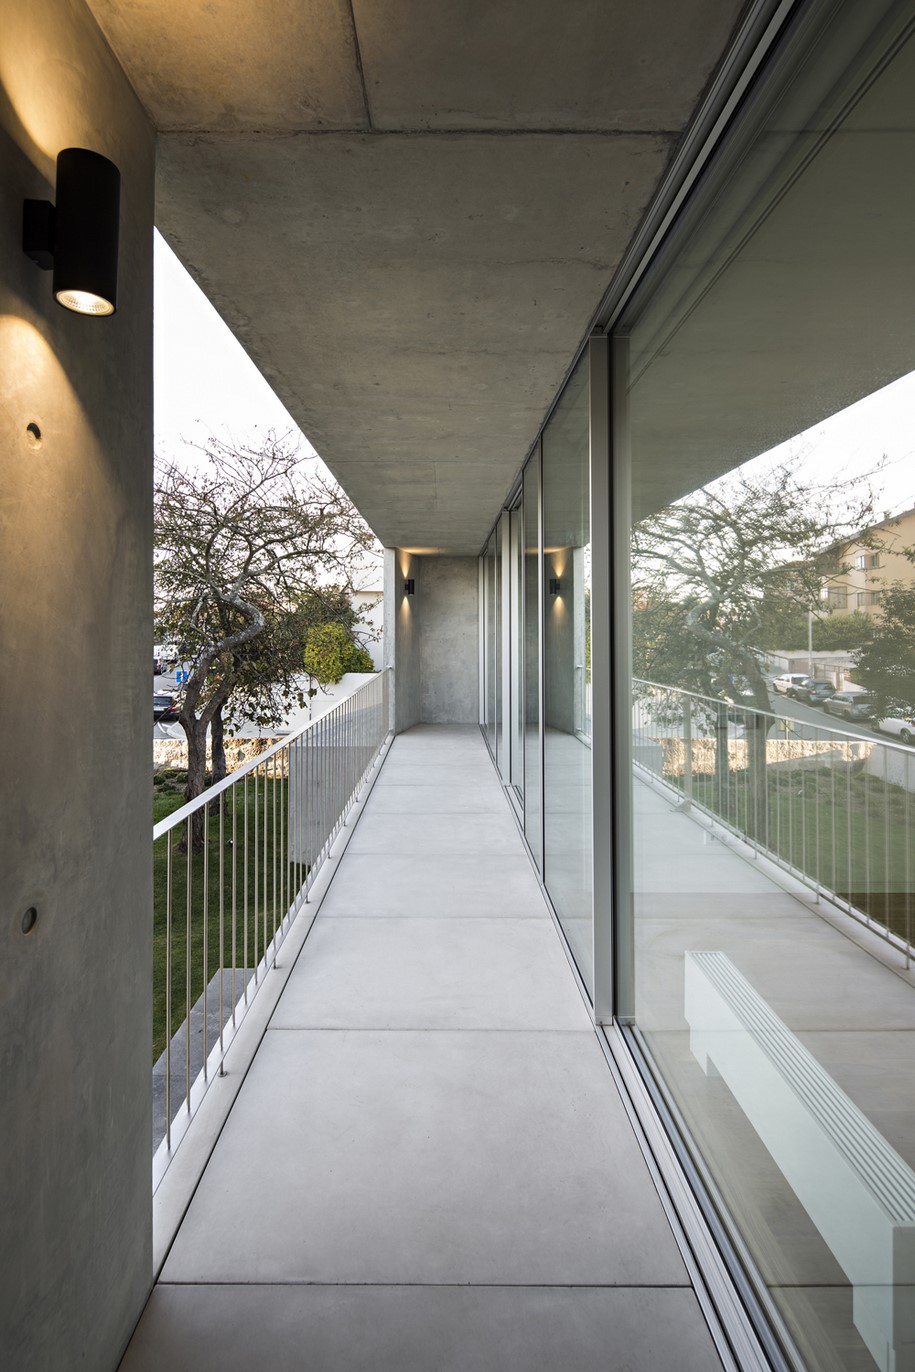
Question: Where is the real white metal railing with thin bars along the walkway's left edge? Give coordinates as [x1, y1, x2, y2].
[152, 670, 390, 1180]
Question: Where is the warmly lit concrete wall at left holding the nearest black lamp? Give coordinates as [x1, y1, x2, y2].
[0, 0, 155, 1372]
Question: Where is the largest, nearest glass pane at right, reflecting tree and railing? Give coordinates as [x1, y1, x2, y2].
[625, 0, 915, 1372]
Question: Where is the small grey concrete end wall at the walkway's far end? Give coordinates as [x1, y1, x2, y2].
[384, 549, 480, 733]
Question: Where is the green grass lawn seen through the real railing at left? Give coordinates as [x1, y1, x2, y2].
[152, 774, 303, 1062]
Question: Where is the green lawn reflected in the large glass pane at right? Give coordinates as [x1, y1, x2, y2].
[691, 767, 915, 940]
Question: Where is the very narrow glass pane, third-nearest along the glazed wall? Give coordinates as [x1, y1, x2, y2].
[524, 454, 543, 870]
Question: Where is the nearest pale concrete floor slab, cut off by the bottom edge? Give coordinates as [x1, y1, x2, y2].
[121, 1284, 720, 1372]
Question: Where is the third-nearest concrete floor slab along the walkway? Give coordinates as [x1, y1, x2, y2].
[272, 918, 590, 1030]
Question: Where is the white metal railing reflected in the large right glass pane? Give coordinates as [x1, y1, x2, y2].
[632, 681, 915, 967]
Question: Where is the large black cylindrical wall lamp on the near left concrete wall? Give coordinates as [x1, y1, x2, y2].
[22, 148, 121, 316]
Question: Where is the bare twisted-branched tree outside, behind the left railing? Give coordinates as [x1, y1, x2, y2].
[155, 434, 372, 823]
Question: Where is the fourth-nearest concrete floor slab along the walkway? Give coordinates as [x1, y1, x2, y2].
[321, 840, 549, 919]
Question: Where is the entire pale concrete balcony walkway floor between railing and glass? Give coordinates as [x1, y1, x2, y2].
[122, 726, 720, 1372]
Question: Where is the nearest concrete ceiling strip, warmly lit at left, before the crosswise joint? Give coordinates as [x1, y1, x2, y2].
[89, 0, 739, 132]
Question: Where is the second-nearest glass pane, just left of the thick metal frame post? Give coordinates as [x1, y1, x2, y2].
[543, 355, 594, 988]
